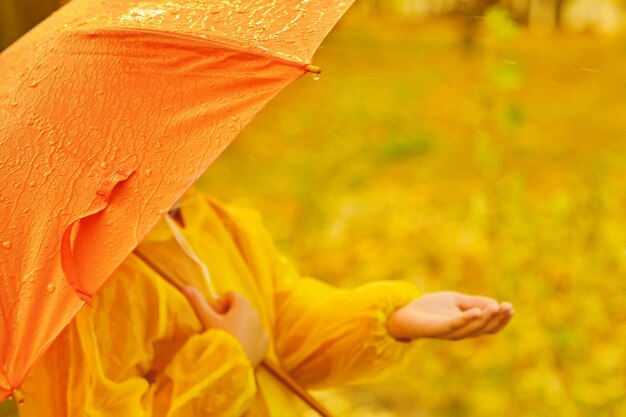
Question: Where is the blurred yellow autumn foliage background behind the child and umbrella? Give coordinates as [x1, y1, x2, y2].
[0, 0, 626, 417]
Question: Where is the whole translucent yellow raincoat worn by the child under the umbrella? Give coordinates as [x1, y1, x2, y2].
[20, 190, 417, 417]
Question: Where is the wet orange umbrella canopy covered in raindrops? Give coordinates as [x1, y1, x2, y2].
[0, 0, 352, 399]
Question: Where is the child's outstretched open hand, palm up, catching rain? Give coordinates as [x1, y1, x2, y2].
[387, 291, 514, 340]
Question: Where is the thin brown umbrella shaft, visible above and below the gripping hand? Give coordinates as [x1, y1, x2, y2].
[133, 248, 333, 417]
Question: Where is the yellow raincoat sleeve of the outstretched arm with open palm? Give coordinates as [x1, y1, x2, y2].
[219, 203, 418, 388]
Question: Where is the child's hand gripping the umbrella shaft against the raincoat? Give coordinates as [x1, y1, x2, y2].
[184, 287, 269, 367]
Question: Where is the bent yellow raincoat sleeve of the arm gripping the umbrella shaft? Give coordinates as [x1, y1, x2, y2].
[70, 257, 256, 417]
